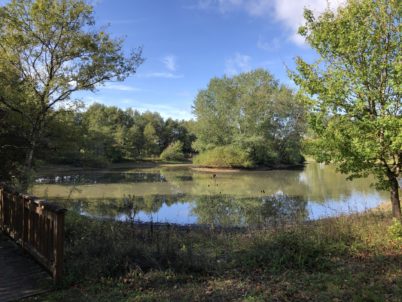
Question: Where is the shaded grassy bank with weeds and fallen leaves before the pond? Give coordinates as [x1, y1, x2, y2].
[25, 211, 402, 302]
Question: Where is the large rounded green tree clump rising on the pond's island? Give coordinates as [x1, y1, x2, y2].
[193, 69, 304, 166]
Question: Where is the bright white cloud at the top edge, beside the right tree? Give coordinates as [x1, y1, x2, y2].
[196, 0, 347, 44]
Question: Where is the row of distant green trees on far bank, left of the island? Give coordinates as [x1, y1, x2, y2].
[30, 104, 195, 167]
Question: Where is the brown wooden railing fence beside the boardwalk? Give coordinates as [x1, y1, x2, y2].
[0, 185, 66, 282]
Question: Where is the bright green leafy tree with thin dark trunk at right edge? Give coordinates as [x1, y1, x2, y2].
[291, 0, 402, 219]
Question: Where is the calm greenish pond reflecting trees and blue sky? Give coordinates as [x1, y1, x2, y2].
[32, 162, 388, 226]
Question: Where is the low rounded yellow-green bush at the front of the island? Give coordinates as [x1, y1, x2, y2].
[193, 146, 254, 168]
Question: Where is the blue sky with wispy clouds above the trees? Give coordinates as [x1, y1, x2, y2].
[77, 0, 342, 119]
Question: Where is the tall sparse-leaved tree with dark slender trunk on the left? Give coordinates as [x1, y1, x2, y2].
[0, 0, 143, 184]
